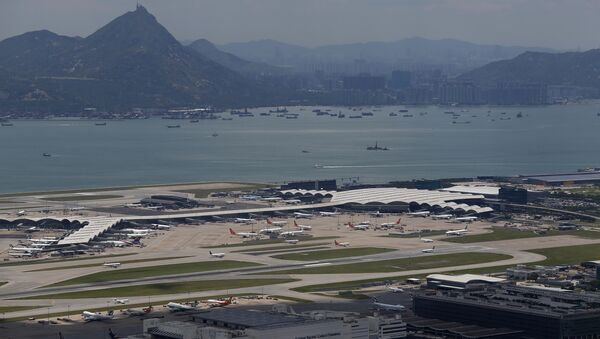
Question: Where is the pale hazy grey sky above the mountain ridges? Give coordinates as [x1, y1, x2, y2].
[0, 0, 600, 49]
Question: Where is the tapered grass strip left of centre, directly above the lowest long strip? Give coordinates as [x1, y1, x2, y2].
[50, 260, 259, 286]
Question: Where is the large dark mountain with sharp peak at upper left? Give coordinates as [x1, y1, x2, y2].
[0, 6, 260, 109]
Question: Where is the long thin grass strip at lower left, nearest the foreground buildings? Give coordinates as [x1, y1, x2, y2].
[20, 279, 297, 299]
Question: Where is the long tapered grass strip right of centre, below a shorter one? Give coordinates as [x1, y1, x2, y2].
[269, 252, 512, 274]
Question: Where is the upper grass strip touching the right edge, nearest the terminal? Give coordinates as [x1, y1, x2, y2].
[442, 227, 600, 244]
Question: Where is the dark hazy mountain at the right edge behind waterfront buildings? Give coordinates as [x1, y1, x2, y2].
[460, 49, 600, 88]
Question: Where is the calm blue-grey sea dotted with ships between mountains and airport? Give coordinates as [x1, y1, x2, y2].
[0, 102, 600, 192]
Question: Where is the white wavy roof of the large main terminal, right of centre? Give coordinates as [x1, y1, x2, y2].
[281, 187, 493, 213]
